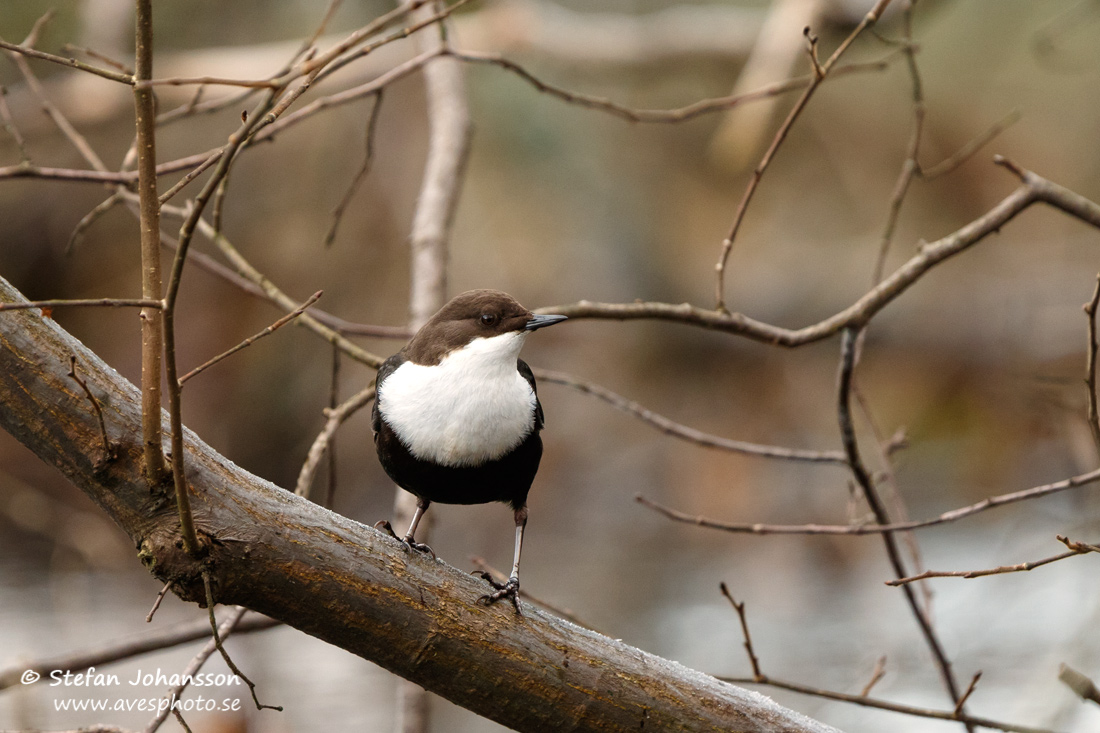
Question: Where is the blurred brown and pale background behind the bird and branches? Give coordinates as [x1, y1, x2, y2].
[0, 0, 1100, 732]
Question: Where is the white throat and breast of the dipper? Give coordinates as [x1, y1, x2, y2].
[378, 332, 536, 467]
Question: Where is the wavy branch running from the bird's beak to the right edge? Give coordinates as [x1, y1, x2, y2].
[538, 167, 1100, 348]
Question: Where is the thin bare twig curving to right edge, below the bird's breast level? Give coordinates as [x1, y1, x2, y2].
[635, 469, 1100, 535]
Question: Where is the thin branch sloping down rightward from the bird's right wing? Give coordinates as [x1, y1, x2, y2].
[535, 369, 847, 466]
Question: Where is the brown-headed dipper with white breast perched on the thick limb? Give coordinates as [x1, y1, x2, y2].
[372, 289, 565, 611]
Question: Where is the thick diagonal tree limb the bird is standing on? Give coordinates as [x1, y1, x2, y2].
[0, 274, 833, 732]
